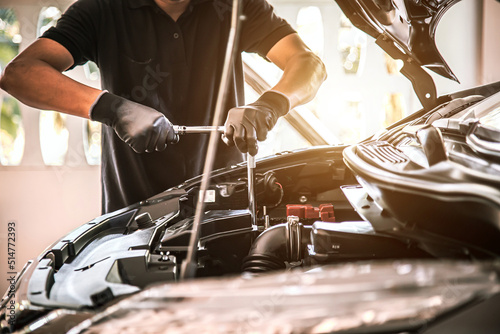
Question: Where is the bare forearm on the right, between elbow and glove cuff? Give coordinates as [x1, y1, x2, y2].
[272, 51, 326, 108]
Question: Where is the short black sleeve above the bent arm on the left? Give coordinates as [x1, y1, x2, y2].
[41, 0, 100, 68]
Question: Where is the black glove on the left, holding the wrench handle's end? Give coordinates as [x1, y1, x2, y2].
[90, 92, 176, 153]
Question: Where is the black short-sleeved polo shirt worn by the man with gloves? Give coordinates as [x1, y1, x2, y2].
[42, 0, 294, 212]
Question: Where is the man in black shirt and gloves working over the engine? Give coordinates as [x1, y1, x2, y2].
[0, 0, 326, 213]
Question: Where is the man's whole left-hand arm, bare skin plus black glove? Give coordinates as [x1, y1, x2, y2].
[0, 38, 175, 153]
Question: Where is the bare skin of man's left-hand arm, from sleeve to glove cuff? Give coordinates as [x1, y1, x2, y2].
[0, 38, 101, 118]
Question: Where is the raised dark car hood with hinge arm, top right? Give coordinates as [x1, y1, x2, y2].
[336, 0, 460, 109]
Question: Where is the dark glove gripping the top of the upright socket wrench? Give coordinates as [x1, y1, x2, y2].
[223, 91, 290, 155]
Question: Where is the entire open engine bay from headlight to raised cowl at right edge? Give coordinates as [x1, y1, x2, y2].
[2, 84, 500, 334]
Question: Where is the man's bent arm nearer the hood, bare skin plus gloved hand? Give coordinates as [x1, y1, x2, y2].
[224, 33, 326, 155]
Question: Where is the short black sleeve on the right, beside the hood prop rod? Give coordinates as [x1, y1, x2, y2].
[240, 0, 295, 57]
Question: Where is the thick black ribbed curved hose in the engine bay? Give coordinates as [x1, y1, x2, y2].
[242, 222, 311, 273]
